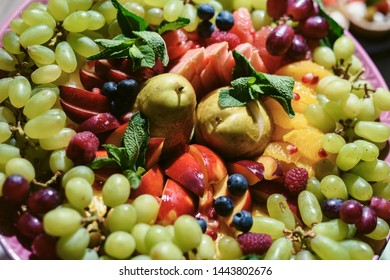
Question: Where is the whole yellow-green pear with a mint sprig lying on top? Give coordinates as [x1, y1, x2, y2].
[195, 87, 273, 159]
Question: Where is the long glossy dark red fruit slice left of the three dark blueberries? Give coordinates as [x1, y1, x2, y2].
[60, 86, 110, 113]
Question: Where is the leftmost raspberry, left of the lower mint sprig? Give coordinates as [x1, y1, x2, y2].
[66, 131, 100, 165]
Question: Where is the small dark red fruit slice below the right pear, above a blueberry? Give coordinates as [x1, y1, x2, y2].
[227, 159, 264, 186]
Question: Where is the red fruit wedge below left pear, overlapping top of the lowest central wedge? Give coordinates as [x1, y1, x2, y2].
[164, 153, 206, 197]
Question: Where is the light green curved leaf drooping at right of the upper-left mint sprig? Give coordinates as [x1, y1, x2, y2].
[133, 31, 169, 66]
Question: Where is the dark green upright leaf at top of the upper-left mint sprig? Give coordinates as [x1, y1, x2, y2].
[111, 0, 149, 38]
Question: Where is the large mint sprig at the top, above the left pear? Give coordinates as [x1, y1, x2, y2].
[88, 0, 189, 71]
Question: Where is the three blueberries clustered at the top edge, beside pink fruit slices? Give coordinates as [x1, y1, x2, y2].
[197, 3, 234, 38]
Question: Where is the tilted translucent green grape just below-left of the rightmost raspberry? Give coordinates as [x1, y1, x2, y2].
[267, 193, 295, 229]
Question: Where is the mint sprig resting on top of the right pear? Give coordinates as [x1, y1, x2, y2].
[218, 51, 295, 117]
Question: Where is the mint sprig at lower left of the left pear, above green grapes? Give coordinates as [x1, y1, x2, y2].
[90, 112, 150, 189]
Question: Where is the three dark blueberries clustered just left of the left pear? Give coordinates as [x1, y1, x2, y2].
[102, 79, 140, 117]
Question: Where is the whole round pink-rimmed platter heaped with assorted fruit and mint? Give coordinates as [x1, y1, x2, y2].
[0, 0, 390, 260]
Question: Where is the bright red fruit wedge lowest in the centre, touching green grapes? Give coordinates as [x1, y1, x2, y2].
[157, 178, 197, 225]
